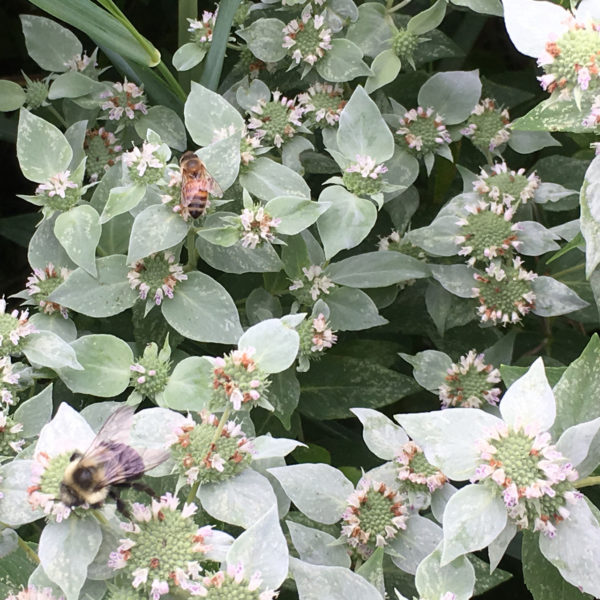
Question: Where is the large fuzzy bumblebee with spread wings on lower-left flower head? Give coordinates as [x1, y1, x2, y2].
[60, 406, 169, 516]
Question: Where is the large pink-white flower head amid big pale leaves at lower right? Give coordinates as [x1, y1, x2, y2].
[472, 424, 582, 537]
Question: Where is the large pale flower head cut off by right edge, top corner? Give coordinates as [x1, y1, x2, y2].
[537, 17, 600, 100]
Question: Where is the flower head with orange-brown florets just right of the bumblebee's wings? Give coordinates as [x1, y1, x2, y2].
[169, 411, 253, 485]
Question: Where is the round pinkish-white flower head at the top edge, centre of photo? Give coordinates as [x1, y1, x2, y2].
[283, 4, 332, 66]
